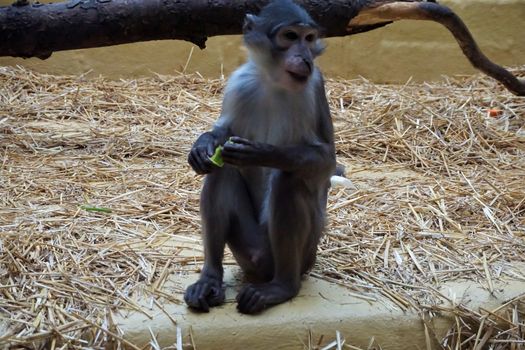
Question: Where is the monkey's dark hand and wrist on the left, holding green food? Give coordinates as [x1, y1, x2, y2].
[188, 126, 231, 175]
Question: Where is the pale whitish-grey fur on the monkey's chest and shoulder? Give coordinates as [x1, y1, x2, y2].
[216, 62, 321, 145]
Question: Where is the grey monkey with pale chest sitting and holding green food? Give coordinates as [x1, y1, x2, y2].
[184, 0, 336, 314]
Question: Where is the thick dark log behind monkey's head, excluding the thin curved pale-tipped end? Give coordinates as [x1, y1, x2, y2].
[0, 0, 377, 59]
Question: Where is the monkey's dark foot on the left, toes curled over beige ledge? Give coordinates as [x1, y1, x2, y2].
[184, 277, 225, 312]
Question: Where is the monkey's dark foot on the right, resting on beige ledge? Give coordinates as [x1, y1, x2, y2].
[237, 282, 297, 314]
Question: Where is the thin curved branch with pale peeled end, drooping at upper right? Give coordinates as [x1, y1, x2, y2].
[349, 0, 525, 96]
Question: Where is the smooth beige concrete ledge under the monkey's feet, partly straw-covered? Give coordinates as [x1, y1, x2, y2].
[115, 268, 525, 350]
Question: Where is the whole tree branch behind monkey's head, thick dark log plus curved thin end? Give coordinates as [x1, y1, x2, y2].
[0, 0, 525, 96]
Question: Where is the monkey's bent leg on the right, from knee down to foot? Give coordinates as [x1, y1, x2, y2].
[237, 171, 322, 314]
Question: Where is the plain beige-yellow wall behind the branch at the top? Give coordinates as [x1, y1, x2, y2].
[0, 0, 525, 82]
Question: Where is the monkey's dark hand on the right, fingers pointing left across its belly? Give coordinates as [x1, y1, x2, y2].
[222, 136, 275, 166]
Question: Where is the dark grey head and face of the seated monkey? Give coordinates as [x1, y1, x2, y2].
[243, 0, 324, 91]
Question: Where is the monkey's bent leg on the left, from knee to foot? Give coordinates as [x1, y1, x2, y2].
[184, 166, 273, 312]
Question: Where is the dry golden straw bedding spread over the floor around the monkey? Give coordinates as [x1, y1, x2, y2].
[0, 67, 525, 349]
